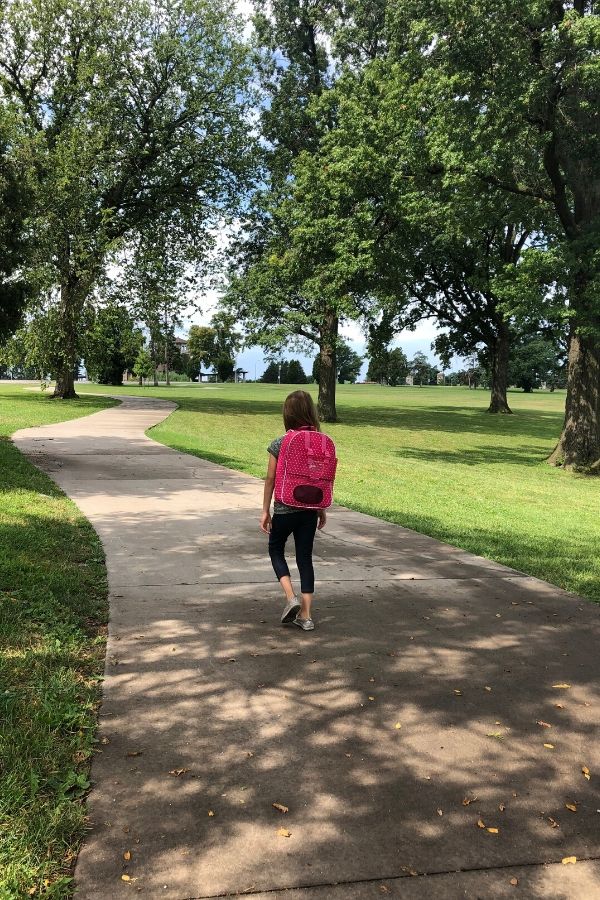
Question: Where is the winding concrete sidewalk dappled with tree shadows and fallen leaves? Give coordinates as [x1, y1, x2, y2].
[14, 398, 600, 900]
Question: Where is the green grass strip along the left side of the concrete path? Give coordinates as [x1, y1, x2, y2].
[0, 385, 116, 900]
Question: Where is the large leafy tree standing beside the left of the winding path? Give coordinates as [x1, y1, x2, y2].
[0, 0, 248, 397]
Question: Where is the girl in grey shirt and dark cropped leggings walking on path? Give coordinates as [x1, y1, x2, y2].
[260, 391, 335, 631]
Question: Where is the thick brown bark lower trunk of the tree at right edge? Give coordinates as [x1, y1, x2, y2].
[548, 331, 600, 474]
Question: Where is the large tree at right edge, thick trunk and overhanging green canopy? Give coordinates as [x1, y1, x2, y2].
[390, 0, 600, 471]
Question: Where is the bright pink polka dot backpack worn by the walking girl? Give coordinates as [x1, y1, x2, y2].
[275, 426, 337, 509]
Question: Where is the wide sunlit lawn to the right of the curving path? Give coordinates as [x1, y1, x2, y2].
[78, 384, 600, 601]
